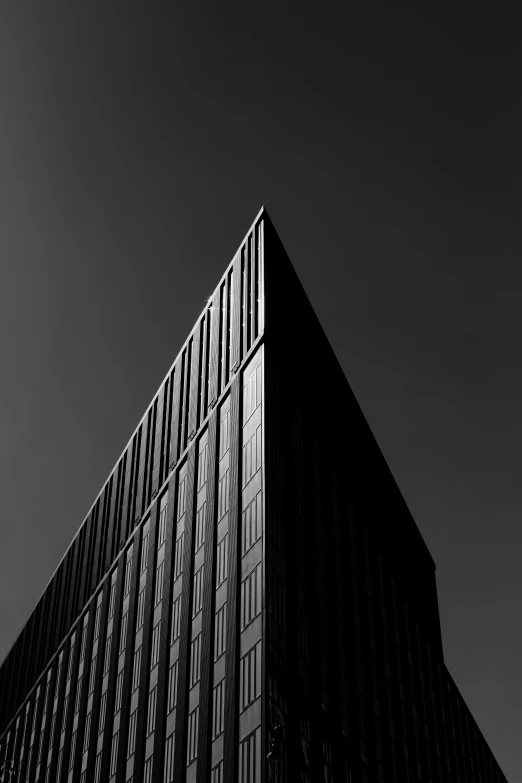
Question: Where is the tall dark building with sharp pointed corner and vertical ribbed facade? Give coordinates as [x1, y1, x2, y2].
[0, 209, 506, 783]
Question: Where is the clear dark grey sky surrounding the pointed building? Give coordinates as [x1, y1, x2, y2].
[0, 1, 522, 781]
